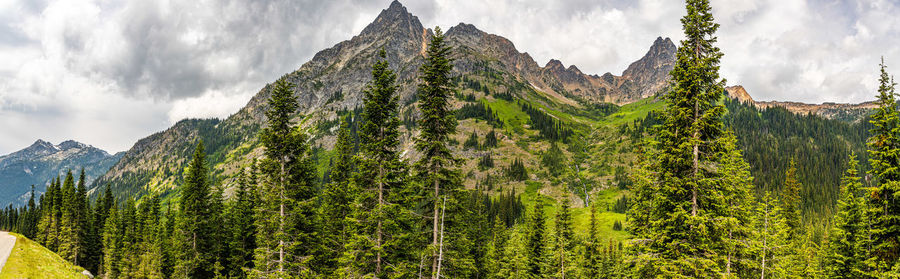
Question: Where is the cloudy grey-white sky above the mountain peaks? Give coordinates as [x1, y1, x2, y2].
[0, 0, 900, 154]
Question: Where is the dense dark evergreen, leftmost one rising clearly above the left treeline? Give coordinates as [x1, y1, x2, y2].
[176, 141, 219, 278]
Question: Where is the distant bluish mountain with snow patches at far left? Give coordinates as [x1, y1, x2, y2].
[0, 140, 124, 206]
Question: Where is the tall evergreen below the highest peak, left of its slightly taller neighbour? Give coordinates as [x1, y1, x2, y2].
[336, 50, 418, 277]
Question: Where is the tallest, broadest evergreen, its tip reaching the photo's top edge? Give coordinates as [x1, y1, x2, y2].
[629, 0, 733, 278]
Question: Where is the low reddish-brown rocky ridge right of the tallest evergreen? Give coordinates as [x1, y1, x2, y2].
[725, 85, 878, 122]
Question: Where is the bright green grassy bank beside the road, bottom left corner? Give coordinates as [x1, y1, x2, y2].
[0, 233, 87, 279]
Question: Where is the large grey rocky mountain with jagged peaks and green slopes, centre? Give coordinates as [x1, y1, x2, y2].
[93, 1, 676, 201]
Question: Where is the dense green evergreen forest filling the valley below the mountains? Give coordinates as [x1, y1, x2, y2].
[0, 0, 900, 278]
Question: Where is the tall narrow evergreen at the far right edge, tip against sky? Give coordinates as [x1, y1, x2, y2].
[866, 58, 900, 273]
